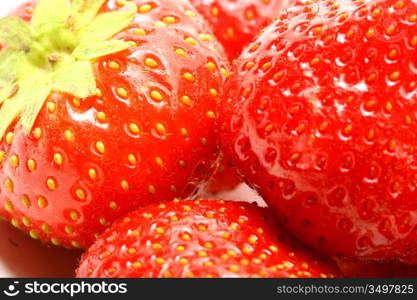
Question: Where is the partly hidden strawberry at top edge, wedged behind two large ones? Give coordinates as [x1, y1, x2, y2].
[191, 0, 289, 60]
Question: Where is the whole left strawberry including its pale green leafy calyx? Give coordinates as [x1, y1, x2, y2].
[0, 0, 227, 248]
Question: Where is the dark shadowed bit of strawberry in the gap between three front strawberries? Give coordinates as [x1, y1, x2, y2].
[206, 158, 242, 194]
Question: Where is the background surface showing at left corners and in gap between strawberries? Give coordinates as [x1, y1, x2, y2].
[0, 0, 262, 277]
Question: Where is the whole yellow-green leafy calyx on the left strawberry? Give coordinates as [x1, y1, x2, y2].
[0, 0, 137, 139]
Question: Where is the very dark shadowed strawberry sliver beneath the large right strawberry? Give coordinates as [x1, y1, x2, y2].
[337, 258, 417, 278]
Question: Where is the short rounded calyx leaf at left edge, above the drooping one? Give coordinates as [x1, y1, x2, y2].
[0, 17, 33, 50]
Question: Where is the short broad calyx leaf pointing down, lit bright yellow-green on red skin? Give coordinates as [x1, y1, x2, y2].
[52, 61, 97, 98]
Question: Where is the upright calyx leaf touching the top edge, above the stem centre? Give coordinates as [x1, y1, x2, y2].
[32, 0, 71, 33]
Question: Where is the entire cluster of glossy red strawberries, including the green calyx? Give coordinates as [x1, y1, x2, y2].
[0, 0, 417, 277]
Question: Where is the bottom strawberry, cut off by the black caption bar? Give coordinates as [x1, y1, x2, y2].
[77, 200, 336, 277]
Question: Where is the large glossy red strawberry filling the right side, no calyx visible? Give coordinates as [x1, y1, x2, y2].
[221, 1, 417, 263]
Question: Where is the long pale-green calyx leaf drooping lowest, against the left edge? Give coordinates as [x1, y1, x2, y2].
[0, 68, 51, 138]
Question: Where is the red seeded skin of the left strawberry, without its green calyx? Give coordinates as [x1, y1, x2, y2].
[0, 0, 226, 248]
